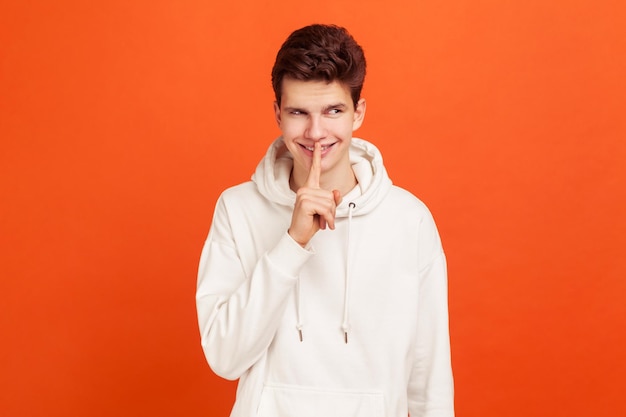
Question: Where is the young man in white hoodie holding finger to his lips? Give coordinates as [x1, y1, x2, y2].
[197, 25, 454, 417]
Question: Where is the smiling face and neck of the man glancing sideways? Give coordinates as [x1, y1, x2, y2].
[274, 78, 365, 186]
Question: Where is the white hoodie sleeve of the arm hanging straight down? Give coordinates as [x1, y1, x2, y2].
[408, 214, 454, 417]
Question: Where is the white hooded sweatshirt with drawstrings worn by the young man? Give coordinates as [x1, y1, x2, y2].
[196, 138, 454, 417]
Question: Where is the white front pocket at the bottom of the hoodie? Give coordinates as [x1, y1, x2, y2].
[257, 385, 385, 417]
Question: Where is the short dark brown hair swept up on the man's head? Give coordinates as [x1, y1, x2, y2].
[272, 24, 365, 107]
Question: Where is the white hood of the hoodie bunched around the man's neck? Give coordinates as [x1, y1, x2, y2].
[252, 137, 391, 217]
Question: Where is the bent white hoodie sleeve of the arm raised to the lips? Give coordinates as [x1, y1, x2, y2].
[196, 196, 312, 379]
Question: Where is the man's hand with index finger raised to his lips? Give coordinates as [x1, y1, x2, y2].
[288, 142, 341, 247]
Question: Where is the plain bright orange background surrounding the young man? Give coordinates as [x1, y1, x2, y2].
[0, 0, 626, 417]
